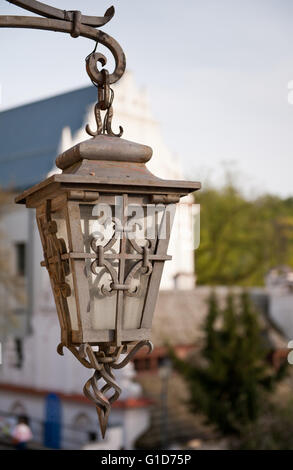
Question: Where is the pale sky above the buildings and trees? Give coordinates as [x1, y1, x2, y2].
[0, 0, 293, 196]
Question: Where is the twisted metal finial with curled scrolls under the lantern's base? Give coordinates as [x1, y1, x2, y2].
[57, 340, 153, 437]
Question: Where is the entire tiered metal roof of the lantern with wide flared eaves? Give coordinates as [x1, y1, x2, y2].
[15, 135, 201, 207]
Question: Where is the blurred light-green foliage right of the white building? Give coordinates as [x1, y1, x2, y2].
[195, 181, 293, 286]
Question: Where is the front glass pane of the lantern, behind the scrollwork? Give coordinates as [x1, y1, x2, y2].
[80, 195, 169, 330]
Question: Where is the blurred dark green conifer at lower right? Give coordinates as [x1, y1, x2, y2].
[173, 293, 282, 434]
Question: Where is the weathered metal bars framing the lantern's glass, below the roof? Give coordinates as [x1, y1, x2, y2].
[32, 187, 178, 346]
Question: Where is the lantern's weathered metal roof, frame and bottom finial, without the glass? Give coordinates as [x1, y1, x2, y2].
[16, 131, 200, 435]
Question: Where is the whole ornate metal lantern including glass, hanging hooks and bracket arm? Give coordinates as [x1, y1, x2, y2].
[0, 0, 200, 435]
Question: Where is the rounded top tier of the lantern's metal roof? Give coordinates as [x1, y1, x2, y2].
[56, 135, 153, 170]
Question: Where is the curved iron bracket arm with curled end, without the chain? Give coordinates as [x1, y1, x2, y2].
[0, 0, 126, 85]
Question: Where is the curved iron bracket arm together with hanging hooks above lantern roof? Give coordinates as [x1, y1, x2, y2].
[0, 0, 126, 137]
